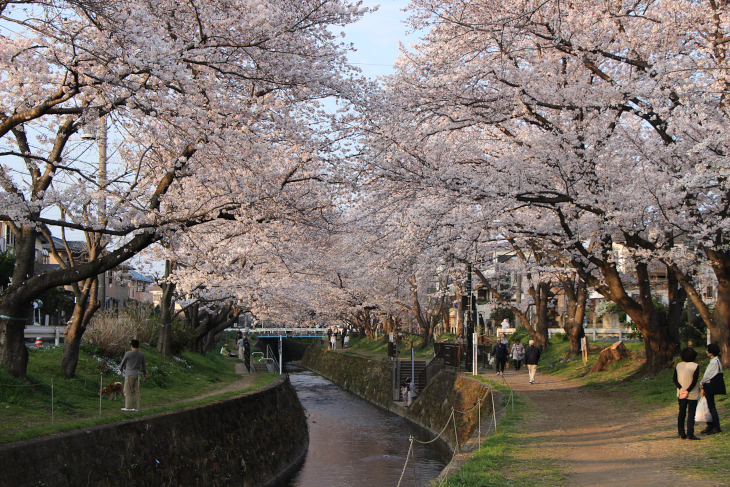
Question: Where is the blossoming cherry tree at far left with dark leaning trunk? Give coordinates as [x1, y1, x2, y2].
[0, 0, 366, 376]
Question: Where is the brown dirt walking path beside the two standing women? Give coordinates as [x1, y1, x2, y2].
[492, 368, 712, 487]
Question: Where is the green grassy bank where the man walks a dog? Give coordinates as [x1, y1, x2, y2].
[0, 345, 276, 443]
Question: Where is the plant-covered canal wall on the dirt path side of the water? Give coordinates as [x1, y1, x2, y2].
[302, 346, 492, 449]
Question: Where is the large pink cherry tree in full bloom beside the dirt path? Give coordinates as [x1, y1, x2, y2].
[358, 0, 728, 373]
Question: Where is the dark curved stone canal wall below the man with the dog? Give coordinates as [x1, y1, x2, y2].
[0, 377, 309, 487]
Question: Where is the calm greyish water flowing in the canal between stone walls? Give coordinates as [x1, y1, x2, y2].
[279, 372, 451, 487]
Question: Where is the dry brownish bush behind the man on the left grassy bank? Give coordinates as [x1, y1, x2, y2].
[82, 303, 158, 357]
